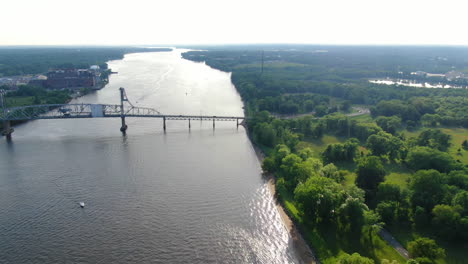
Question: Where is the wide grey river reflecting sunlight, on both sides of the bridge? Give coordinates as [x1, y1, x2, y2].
[0, 50, 298, 263]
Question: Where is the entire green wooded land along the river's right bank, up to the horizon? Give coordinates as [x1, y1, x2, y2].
[183, 45, 468, 264]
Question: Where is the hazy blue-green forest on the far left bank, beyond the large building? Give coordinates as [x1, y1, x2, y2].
[0, 46, 171, 77]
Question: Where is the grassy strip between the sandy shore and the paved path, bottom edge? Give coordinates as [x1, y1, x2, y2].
[279, 186, 405, 264]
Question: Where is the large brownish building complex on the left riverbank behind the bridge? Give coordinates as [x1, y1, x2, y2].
[45, 69, 99, 89]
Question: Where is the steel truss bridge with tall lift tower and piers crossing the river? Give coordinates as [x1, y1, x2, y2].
[0, 88, 245, 140]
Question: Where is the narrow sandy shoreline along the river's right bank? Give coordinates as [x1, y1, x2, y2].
[252, 142, 320, 264]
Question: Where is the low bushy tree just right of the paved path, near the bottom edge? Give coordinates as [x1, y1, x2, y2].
[408, 237, 445, 261]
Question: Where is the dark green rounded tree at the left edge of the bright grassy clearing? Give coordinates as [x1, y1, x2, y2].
[356, 156, 385, 198]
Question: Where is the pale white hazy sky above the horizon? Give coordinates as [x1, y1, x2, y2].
[0, 0, 468, 45]
